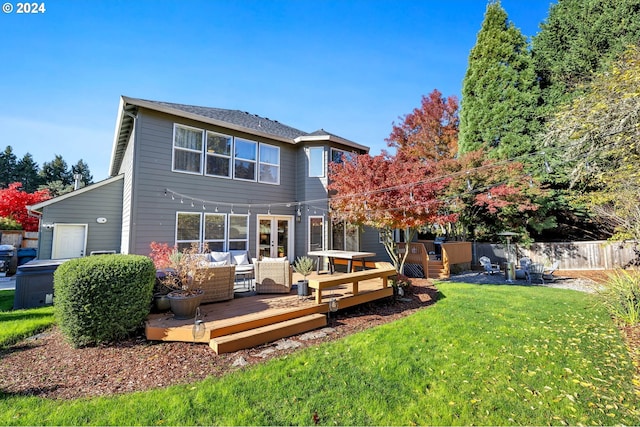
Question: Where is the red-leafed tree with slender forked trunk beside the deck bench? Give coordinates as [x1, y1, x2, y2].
[329, 152, 457, 272]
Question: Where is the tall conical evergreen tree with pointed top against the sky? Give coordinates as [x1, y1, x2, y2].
[459, 1, 540, 159]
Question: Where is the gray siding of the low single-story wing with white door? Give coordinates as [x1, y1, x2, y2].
[38, 179, 123, 259]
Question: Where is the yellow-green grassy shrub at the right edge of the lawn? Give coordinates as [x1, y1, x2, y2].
[599, 270, 640, 325]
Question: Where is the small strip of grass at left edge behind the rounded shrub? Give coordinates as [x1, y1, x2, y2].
[0, 290, 54, 348]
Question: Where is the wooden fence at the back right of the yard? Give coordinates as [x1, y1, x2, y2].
[472, 240, 637, 270]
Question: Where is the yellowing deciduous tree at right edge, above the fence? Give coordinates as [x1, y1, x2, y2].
[545, 46, 640, 244]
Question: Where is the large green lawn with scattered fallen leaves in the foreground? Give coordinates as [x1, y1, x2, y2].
[0, 283, 640, 425]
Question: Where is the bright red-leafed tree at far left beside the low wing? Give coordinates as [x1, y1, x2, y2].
[0, 182, 51, 231]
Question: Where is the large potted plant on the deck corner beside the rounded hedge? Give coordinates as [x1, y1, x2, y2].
[152, 243, 206, 319]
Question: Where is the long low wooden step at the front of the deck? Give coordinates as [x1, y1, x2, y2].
[209, 314, 327, 354]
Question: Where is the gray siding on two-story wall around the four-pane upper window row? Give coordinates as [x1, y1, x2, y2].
[130, 109, 298, 255]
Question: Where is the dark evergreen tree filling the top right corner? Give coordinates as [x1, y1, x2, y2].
[532, 0, 640, 113]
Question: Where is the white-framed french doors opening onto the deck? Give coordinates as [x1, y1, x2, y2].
[257, 215, 293, 261]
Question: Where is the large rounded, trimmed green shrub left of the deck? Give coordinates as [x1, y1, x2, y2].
[54, 255, 156, 347]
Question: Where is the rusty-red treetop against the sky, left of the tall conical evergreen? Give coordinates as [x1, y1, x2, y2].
[385, 89, 460, 161]
